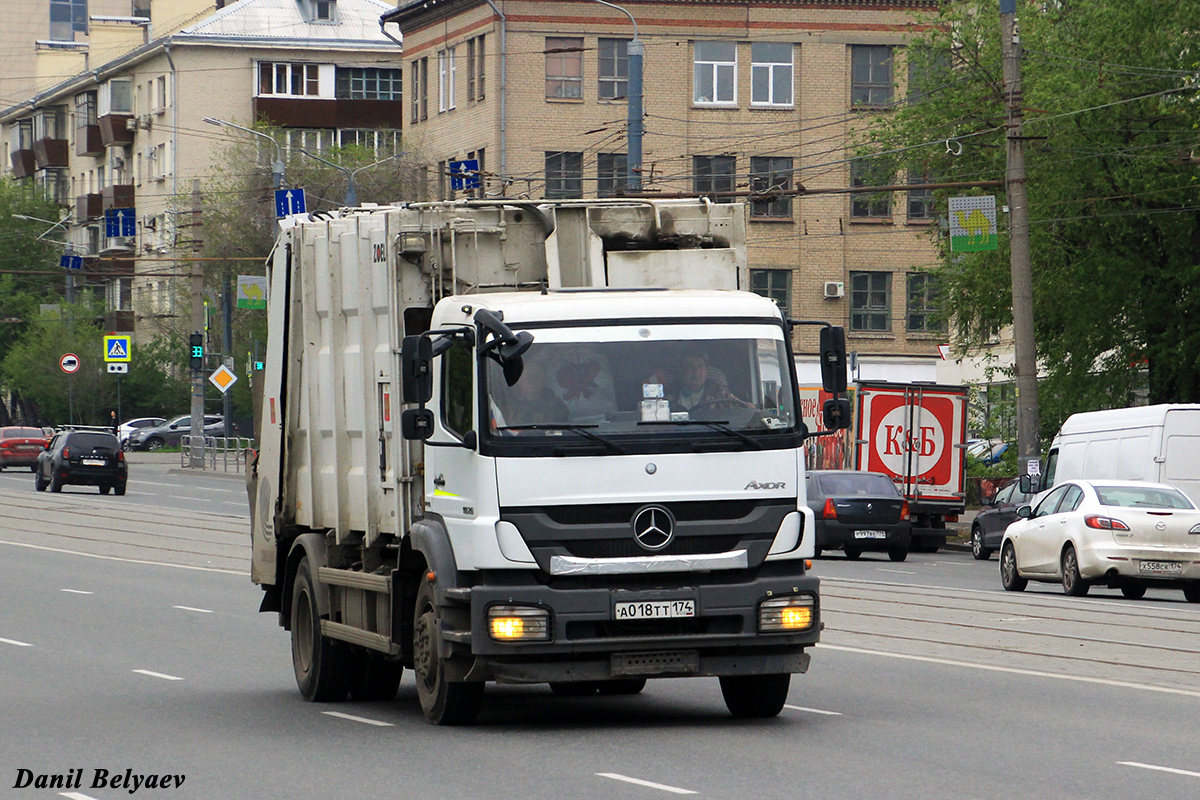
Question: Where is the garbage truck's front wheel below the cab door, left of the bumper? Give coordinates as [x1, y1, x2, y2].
[413, 577, 484, 724]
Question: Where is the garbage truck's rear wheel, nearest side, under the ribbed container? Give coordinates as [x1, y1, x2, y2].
[292, 555, 348, 703]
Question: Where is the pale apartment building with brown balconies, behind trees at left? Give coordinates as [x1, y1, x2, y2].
[0, 0, 403, 337]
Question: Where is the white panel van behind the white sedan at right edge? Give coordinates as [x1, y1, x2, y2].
[1040, 403, 1200, 504]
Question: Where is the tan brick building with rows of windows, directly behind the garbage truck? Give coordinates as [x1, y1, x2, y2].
[385, 0, 947, 371]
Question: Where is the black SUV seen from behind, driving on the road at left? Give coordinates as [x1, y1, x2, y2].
[34, 428, 130, 494]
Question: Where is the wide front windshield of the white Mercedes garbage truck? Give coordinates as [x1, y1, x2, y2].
[485, 324, 800, 451]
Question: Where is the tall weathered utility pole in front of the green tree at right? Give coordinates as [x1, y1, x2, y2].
[1000, 0, 1040, 475]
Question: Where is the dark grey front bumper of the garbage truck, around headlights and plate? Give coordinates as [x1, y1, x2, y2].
[442, 570, 822, 682]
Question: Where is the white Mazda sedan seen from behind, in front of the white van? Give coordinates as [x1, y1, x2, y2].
[1000, 481, 1200, 603]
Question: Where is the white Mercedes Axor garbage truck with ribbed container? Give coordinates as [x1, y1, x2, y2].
[247, 200, 850, 724]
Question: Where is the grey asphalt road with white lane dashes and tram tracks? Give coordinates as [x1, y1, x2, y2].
[0, 484, 1200, 800]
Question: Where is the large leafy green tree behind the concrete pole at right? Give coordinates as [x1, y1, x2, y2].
[856, 0, 1200, 434]
